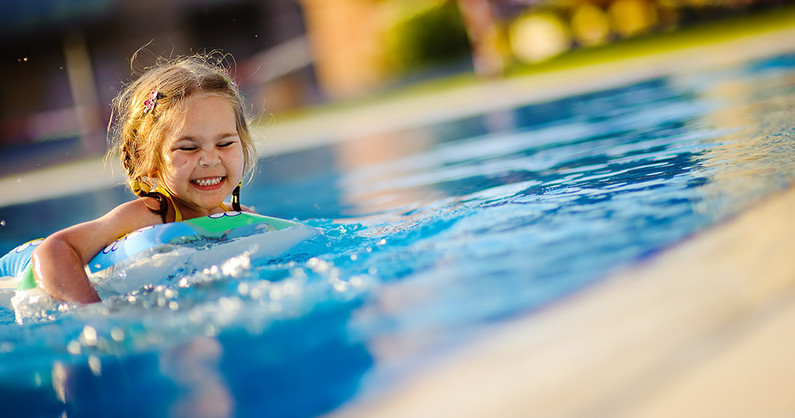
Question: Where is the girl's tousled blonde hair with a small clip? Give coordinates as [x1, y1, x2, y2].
[108, 53, 256, 196]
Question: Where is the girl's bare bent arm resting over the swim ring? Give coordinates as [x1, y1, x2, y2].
[33, 199, 161, 303]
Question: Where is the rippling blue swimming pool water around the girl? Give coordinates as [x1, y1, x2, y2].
[0, 52, 795, 416]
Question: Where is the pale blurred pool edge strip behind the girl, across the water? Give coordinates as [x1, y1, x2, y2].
[0, 27, 795, 207]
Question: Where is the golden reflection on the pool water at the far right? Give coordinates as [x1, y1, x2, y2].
[674, 56, 795, 210]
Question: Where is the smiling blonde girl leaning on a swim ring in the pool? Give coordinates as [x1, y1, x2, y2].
[32, 56, 256, 303]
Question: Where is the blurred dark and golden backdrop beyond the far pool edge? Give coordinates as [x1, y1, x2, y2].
[0, 0, 788, 176]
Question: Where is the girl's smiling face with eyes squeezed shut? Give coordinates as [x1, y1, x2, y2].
[160, 94, 243, 217]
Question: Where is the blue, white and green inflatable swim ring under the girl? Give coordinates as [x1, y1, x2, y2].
[0, 212, 312, 290]
